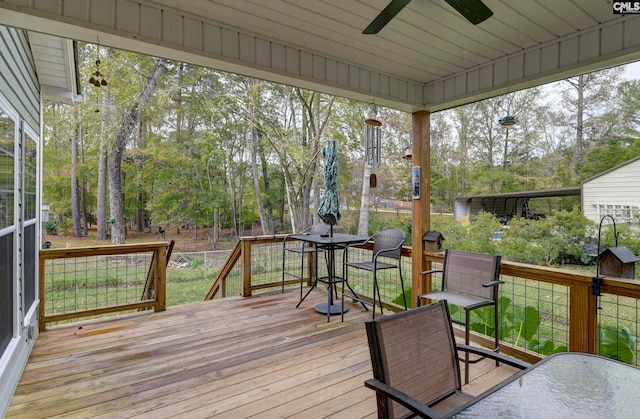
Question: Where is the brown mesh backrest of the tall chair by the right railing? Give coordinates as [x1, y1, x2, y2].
[442, 249, 501, 300]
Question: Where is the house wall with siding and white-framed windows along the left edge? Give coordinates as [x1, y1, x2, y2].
[0, 26, 41, 417]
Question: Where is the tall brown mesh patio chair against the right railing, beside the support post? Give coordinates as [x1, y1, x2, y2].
[418, 249, 504, 384]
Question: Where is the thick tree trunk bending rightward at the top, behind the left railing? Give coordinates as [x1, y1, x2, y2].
[109, 59, 168, 244]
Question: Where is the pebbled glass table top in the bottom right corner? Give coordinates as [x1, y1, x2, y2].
[454, 353, 640, 418]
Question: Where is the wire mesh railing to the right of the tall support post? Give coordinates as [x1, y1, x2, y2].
[424, 253, 640, 366]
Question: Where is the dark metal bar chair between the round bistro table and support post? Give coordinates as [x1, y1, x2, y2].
[342, 229, 407, 319]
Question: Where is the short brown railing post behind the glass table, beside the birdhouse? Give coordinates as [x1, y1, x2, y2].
[569, 284, 597, 354]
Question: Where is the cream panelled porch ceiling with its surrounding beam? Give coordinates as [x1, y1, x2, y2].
[0, 0, 640, 111]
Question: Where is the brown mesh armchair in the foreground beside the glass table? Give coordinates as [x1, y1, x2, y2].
[365, 301, 529, 418]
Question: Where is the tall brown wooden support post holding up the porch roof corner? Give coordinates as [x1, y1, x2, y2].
[411, 111, 431, 307]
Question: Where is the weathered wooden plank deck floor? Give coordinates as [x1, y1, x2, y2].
[8, 290, 514, 418]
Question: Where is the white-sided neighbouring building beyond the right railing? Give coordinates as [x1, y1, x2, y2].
[582, 157, 640, 223]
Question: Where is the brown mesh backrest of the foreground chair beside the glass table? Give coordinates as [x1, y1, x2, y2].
[365, 301, 461, 418]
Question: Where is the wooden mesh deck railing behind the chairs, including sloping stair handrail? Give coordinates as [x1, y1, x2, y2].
[206, 236, 640, 364]
